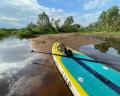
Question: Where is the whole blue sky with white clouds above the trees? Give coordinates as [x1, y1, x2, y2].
[0, 0, 120, 28]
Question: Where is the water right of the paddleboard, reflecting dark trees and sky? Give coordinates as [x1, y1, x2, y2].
[80, 38, 120, 71]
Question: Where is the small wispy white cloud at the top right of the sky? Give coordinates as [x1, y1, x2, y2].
[84, 0, 110, 10]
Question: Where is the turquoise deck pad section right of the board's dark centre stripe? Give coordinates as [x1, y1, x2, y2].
[74, 54, 120, 87]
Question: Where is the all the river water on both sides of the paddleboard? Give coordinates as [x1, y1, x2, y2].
[0, 37, 120, 96]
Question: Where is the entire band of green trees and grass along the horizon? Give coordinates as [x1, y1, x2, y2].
[0, 6, 120, 37]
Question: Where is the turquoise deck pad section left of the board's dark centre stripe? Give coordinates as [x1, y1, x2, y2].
[61, 57, 119, 96]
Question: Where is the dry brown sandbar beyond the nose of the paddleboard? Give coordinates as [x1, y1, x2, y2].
[31, 33, 101, 56]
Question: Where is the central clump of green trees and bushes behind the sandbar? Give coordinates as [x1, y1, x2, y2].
[26, 12, 81, 34]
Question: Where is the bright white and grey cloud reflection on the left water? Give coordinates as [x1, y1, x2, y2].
[0, 37, 37, 78]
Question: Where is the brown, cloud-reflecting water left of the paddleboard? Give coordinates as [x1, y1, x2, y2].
[0, 37, 72, 96]
